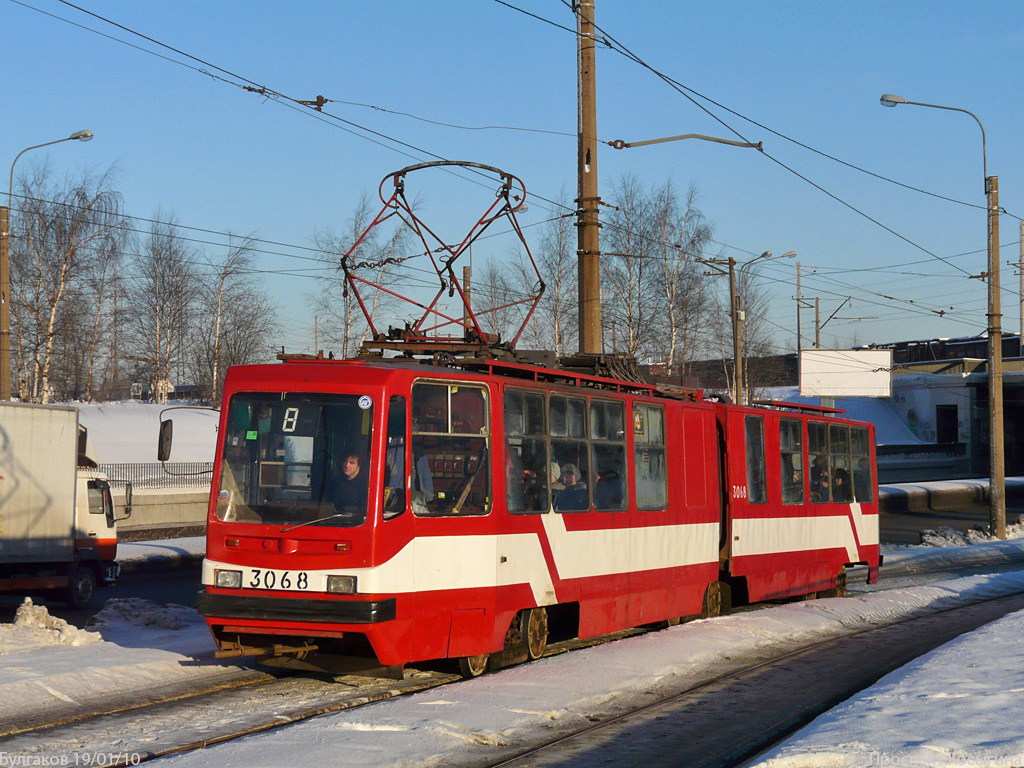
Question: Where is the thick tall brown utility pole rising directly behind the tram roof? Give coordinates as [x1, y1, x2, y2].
[575, 0, 602, 354]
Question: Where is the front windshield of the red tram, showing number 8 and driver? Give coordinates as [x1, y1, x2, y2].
[217, 392, 374, 530]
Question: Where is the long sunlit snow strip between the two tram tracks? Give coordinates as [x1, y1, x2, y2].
[151, 573, 1024, 768]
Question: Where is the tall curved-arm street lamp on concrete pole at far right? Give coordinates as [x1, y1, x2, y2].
[880, 93, 1007, 539]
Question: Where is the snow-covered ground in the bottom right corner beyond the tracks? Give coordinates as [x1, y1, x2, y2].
[757, 612, 1024, 768]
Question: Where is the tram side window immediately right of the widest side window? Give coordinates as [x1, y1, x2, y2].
[504, 389, 551, 513]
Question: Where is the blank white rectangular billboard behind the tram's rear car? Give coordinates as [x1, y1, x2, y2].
[800, 349, 893, 397]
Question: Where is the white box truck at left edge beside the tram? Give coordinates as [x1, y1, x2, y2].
[0, 402, 131, 608]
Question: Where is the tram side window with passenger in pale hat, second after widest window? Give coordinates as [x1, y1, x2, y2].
[549, 394, 591, 512]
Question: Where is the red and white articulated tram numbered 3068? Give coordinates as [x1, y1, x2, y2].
[193, 358, 880, 676]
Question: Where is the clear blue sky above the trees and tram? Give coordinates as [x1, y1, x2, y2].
[0, 0, 1024, 358]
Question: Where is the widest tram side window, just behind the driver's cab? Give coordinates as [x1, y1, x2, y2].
[411, 382, 490, 516]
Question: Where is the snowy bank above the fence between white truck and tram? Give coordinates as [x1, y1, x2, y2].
[76, 400, 220, 464]
